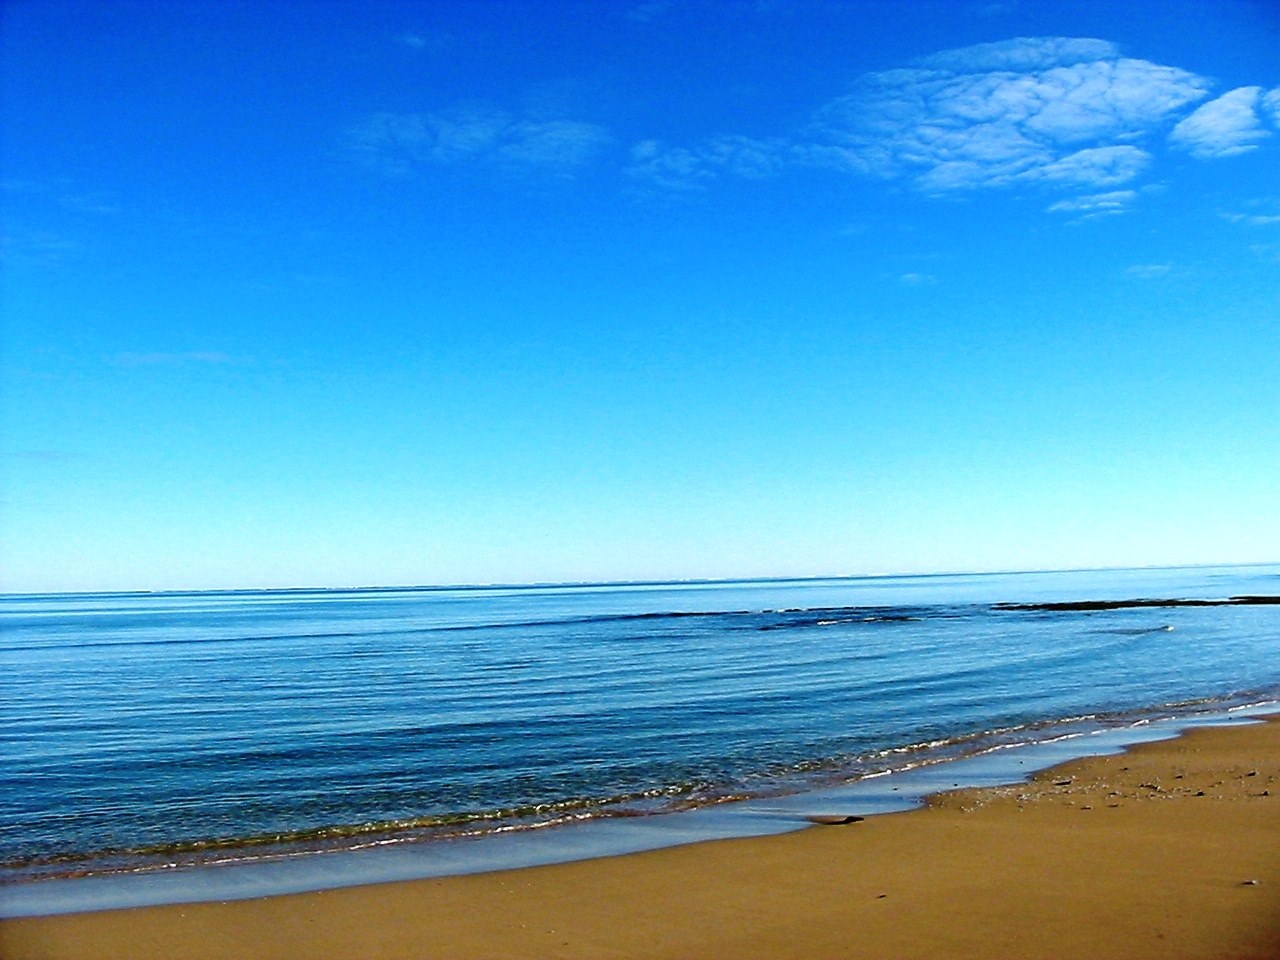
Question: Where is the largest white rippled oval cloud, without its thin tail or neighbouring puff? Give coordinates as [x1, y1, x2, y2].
[818, 37, 1208, 192]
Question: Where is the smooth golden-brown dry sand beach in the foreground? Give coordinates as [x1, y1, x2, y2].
[0, 718, 1280, 960]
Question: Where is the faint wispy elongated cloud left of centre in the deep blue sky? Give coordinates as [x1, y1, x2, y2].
[349, 106, 612, 175]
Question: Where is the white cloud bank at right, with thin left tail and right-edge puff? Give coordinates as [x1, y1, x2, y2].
[628, 37, 1280, 216]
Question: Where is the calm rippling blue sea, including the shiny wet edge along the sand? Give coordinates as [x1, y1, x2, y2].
[0, 564, 1280, 915]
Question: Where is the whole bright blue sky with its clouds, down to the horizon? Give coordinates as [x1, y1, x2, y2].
[0, 0, 1280, 591]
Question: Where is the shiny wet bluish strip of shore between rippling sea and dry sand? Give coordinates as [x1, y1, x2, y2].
[0, 691, 1280, 920]
